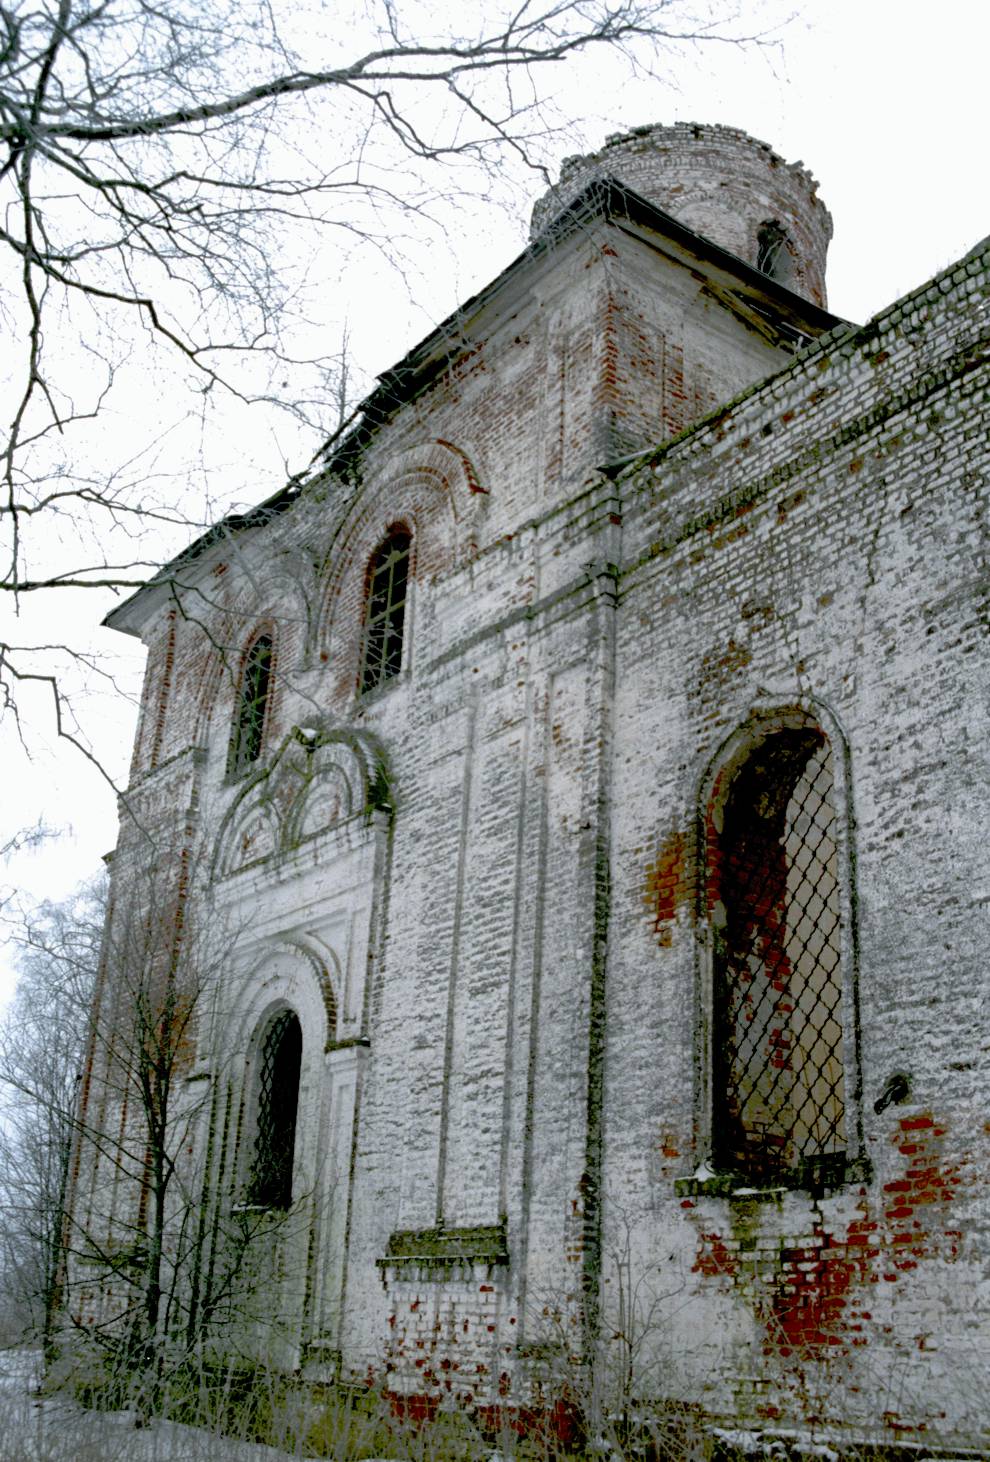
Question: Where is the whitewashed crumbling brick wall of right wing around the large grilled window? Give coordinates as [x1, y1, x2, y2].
[605, 225, 987, 1434]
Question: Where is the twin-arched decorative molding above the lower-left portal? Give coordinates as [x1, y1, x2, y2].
[211, 727, 392, 879]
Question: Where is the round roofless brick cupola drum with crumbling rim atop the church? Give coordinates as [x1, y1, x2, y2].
[532, 121, 832, 306]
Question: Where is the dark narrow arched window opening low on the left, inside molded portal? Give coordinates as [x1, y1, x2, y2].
[247, 1010, 303, 1209]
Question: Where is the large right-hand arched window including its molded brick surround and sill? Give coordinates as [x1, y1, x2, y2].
[699, 703, 863, 1187]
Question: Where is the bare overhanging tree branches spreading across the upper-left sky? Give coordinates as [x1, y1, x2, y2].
[0, 0, 766, 771]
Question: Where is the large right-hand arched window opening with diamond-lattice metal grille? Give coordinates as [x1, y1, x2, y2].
[712, 727, 845, 1183]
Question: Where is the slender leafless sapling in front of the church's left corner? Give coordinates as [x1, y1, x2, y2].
[58, 857, 209, 1380]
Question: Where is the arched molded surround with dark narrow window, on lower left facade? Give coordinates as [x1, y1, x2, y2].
[194, 937, 345, 1367]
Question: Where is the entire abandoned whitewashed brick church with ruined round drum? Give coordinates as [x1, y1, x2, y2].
[70, 124, 990, 1446]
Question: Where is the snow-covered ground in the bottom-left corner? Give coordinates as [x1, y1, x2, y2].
[0, 1351, 314, 1462]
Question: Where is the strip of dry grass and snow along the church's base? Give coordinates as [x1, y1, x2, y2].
[0, 1351, 986, 1462]
